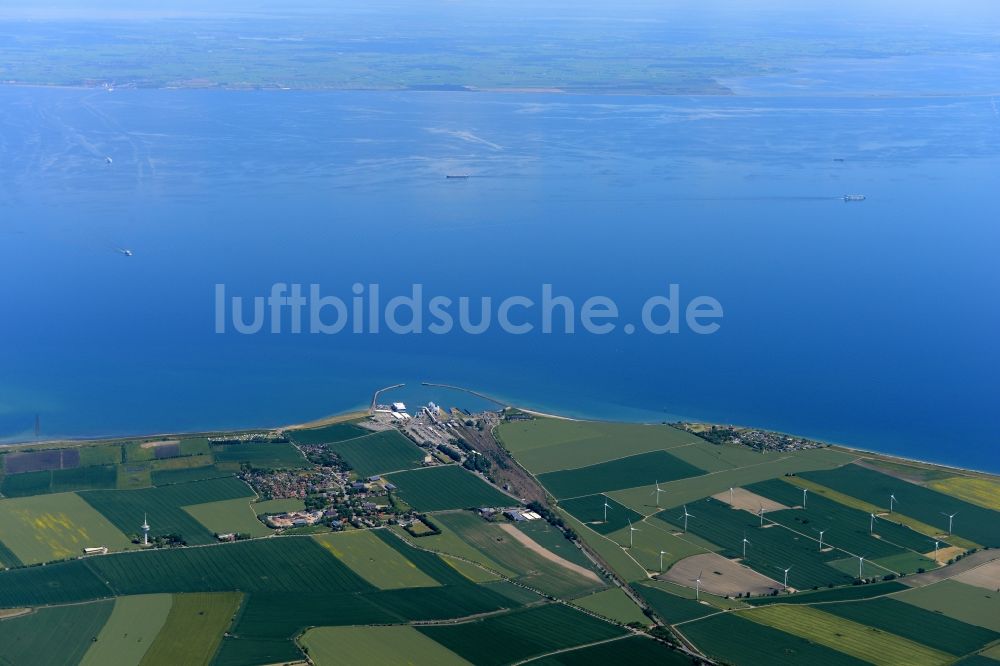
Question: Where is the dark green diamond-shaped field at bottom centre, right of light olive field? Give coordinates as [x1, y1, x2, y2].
[417, 604, 625, 666]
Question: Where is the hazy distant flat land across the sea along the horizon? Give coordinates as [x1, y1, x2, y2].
[0, 2, 993, 95]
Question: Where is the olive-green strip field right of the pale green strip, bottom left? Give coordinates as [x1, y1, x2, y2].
[140, 592, 242, 666]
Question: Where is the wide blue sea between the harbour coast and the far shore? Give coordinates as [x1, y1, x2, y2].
[0, 79, 1000, 471]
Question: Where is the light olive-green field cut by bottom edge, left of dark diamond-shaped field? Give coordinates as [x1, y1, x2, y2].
[301, 625, 469, 666]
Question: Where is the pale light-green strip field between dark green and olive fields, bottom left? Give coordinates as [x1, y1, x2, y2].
[81, 594, 173, 666]
